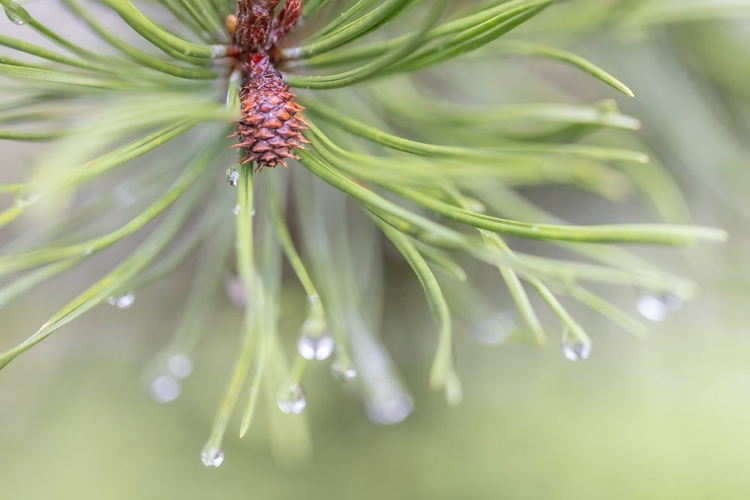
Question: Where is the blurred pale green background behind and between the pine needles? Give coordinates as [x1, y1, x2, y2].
[0, 0, 750, 500]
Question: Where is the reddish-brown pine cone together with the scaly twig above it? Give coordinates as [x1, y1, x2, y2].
[232, 0, 308, 171]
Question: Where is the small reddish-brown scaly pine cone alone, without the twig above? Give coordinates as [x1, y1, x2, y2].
[232, 56, 308, 171]
